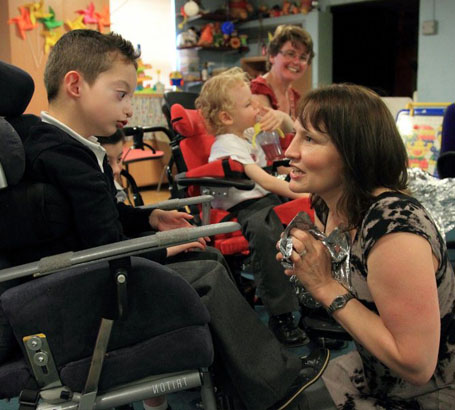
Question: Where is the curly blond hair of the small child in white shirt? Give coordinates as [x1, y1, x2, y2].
[196, 67, 249, 135]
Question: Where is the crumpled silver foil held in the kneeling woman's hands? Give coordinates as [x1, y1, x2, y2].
[279, 212, 352, 308]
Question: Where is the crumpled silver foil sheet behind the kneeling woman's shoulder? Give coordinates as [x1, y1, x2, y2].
[408, 168, 455, 237]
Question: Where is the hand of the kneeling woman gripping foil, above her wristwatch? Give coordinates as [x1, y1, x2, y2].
[277, 228, 335, 300]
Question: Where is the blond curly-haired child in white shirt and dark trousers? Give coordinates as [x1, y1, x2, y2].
[196, 68, 309, 346]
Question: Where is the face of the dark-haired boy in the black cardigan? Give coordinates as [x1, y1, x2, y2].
[79, 56, 137, 137]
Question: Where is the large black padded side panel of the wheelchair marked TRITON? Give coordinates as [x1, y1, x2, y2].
[0, 257, 213, 397]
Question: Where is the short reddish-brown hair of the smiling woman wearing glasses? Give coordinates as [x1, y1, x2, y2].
[267, 24, 314, 70]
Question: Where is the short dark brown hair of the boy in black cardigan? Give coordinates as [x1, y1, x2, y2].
[44, 30, 140, 101]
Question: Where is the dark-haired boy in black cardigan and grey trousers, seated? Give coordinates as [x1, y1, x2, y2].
[17, 30, 329, 410]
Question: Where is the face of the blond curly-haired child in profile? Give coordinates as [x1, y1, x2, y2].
[226, 84, 259, 138]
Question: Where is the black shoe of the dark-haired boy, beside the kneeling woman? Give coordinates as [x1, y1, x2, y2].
[268, 348, 330, 410]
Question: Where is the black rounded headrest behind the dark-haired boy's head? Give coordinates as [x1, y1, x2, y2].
[0, 61, 35, 117]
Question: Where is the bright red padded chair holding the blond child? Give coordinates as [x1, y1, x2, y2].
[171, 104, 313, 256]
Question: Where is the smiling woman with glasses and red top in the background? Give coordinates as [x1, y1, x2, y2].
[250, 25, 314, 133]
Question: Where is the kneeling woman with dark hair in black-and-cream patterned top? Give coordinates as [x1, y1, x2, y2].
[278, 85, 455, 410]
